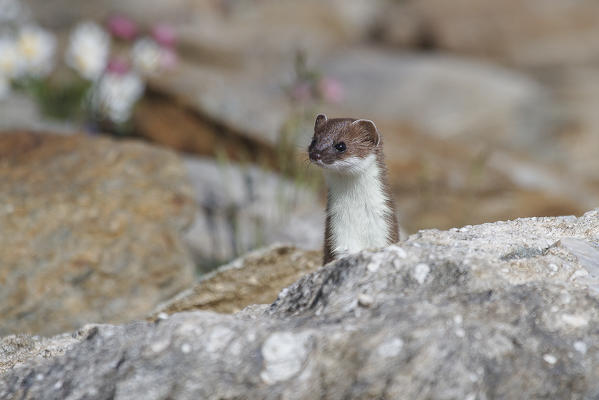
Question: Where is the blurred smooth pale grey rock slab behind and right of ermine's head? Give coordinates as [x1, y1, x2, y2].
[322, 49, 550, 148]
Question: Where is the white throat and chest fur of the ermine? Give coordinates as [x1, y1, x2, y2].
[325, 155, 392, 256]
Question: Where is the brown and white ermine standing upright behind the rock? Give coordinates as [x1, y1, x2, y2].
[308, 114, 399, 264]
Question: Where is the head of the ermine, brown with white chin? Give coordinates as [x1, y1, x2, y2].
[308, 114, 380, 174]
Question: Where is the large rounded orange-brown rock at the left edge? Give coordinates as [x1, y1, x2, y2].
[0, 132, 195, 335]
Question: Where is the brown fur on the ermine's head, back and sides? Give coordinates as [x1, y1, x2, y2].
[308, 115, 399, 264]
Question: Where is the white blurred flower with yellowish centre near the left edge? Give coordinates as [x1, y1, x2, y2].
[17, 26, 56, 76]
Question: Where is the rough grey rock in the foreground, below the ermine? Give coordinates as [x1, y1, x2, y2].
[0, 209, 599, 399]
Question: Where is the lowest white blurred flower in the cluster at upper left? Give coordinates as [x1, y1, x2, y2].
[92, 72, 144, 124]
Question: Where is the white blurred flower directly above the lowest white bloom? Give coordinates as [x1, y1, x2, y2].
[66, 22, 110, 81]
